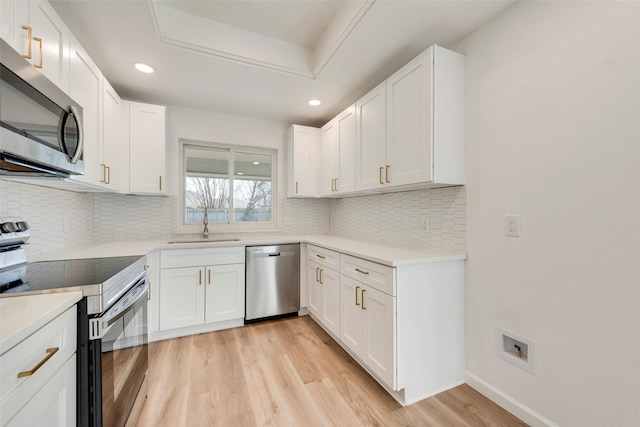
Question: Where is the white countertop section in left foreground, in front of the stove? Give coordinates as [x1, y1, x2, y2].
[0, 291, 82, 354]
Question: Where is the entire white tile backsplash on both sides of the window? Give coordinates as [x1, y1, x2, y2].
[0, 180, 467, 259]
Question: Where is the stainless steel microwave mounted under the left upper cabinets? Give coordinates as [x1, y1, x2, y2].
[0, 39, 84, 177]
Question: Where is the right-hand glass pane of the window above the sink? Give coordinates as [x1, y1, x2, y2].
[233, 152, 272, 222]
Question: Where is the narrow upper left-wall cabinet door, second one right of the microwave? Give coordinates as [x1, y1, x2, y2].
[102, 79, 122, 191]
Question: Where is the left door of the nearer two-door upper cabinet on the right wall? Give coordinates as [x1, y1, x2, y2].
[356, 82, 387, 190]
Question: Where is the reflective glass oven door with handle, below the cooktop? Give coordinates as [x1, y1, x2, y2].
[95, 277, 149, 426]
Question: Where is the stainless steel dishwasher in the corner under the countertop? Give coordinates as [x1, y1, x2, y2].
[244, 243, 300, 322]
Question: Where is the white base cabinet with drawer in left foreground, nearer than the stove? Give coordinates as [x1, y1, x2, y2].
[0, 305, 77, 427]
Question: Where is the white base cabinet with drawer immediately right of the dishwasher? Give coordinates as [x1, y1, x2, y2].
[307, 245, 340, 337]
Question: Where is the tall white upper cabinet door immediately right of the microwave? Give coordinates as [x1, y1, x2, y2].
[69, 40, 106, 186]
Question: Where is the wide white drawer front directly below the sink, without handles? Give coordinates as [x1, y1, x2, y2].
[160, 246, 244, 268]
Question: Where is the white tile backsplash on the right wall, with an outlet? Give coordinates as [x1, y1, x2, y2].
[329, 187, 467, 252]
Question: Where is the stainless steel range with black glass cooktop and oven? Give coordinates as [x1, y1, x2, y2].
[0, 221, 149, 427]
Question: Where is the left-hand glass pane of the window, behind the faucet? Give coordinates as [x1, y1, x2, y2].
[185, 145, 230, 224]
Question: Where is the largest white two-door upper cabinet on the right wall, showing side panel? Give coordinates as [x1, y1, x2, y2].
[356, 46, 464, 191]
